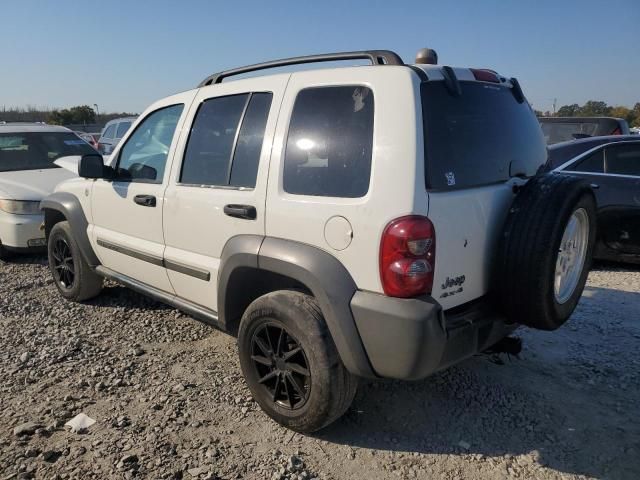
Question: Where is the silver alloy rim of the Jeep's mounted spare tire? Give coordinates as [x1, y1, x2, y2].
[553, 208, 589, 304]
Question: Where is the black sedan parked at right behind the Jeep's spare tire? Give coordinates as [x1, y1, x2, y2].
[549, 135, 640, 263]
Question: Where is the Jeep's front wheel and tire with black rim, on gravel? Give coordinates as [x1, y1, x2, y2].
[47, 221, 102, 302]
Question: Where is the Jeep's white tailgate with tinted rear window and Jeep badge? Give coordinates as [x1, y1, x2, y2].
[422, 76, 547, 309]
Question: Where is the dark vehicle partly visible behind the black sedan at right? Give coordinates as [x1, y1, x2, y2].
[538, 117, 630, 145]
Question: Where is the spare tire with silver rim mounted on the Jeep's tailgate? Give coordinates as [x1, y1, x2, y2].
[494, 173, 596, 330]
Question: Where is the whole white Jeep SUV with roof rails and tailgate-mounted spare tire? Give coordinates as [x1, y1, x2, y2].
[42, 51, 595, 432]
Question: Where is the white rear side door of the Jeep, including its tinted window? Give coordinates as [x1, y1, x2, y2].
[164, 75, 289, 311]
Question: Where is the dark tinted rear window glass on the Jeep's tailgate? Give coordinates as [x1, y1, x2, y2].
[421, 82, 547, 190]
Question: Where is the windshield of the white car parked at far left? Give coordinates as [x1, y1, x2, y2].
[0, 132, 96, 172]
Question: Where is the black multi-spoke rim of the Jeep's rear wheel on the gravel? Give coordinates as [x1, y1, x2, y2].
[251, 323, 311, 410]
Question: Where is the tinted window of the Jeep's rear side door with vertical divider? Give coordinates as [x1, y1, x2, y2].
[180, 93, 272, 188]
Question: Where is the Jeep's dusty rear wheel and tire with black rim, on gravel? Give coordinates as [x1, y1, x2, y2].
[238, 290, 357, 433]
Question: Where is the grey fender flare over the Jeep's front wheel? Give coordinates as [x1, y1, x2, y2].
[40, 192, 100, 268]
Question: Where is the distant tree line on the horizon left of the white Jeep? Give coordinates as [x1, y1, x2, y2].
[0, 105, 137, 125]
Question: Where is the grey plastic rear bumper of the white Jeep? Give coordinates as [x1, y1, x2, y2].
[351, 291, 516, 380]
